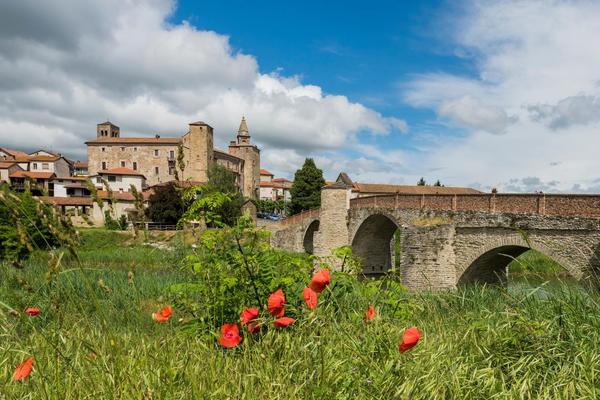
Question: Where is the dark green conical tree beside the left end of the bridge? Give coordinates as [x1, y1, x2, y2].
[290, 158, 325, 215]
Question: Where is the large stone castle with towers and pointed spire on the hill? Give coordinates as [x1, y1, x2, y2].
[86, 118, 260, 198]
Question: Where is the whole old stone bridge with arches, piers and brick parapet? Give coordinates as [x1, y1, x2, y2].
[271, 182, 600, 289]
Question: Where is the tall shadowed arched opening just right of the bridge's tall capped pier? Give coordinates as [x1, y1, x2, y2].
[352, 214, 400, 276]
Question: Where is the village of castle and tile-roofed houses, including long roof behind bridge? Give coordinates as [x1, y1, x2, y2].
[0, 117, 479, 225]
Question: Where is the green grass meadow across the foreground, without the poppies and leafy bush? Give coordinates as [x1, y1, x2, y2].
[0, 230, 600, 400]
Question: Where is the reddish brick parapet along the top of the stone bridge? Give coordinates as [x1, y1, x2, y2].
[350, 193, 600, 218]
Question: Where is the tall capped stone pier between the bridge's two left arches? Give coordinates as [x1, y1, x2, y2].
[314, 182, 351, 268]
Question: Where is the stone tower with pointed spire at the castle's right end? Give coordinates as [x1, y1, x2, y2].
[229, 117, 260, 199]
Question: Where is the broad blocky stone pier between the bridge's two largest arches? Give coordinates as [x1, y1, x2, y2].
[400, 221, 456, 290]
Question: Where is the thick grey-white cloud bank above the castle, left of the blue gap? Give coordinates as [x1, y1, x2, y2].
[0, 0, 408, 163]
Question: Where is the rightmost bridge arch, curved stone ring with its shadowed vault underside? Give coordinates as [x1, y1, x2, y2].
[456, 234, 584, 286]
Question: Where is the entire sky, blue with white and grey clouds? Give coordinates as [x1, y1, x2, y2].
[0, 0, 600, 192]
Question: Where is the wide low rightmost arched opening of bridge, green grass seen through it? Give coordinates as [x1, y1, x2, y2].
[458, 245, 576, 287]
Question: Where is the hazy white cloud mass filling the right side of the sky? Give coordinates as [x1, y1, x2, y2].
[401, 0, 600, 191]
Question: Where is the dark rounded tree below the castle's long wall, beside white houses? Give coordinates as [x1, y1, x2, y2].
[146, 182, 184, 225]
